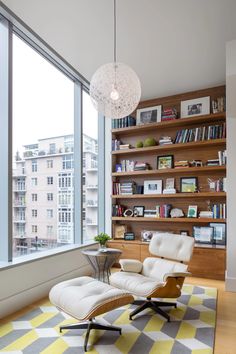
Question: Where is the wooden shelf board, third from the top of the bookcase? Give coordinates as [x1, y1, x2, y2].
[112, 166, 226, 177]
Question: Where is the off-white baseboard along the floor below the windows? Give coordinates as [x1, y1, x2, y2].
[0, 265, 91, 319]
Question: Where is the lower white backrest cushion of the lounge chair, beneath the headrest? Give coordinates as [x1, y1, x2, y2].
[142, 257, 188, 282]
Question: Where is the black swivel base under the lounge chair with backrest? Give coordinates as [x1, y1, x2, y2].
[129, 298, 177, 322]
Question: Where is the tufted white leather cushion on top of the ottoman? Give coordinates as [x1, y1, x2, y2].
[49, 277, 132, 320]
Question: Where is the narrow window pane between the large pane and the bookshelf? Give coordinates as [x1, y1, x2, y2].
[82, 91, 98, 242]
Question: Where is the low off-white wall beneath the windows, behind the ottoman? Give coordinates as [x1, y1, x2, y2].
[0, 249, 94, 318]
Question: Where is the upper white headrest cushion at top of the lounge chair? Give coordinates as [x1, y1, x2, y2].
[149, 233, 194, 262]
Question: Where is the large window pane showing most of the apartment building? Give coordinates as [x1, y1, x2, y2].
[13, 35, 74, 257]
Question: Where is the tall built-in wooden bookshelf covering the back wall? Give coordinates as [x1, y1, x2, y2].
[109, 86, 226, 279]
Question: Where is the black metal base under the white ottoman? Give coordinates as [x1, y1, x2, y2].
[60, 318, 121, 352]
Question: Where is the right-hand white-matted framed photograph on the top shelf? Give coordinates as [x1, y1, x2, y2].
[181, 96, 210, 118]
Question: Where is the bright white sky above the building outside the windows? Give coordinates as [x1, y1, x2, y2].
[13, 35, 97, 155]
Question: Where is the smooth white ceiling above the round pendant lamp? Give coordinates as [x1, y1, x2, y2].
[3, 0, 236, 99]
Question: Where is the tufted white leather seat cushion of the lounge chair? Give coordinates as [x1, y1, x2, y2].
[110, 272, 163, 297]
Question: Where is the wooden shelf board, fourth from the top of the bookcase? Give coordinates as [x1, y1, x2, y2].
[112, 192, 226, 199]
